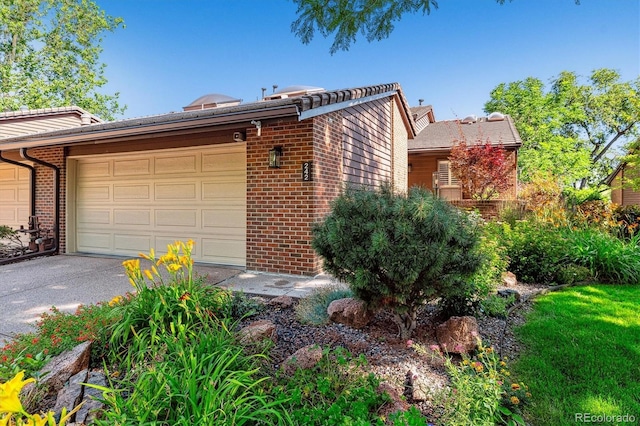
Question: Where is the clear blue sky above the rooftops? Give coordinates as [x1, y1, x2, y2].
[97, 0, 640, 120]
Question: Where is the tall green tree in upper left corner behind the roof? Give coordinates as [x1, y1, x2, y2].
[0, 0, 124, 119]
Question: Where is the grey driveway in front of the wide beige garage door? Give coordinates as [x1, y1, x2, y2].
[0, 255, 241, 345]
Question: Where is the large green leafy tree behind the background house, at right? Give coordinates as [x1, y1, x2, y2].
[485, 68, 640, 188]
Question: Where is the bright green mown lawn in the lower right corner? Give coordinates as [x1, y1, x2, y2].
[513, 285, 640, 425]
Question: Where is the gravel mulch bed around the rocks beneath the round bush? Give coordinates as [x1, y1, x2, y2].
[242, 284, 548, 414]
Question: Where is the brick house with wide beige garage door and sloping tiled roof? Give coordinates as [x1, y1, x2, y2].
[0, 83, 415, 275]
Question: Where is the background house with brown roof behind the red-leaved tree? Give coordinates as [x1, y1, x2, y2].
[408, 112, 522, 200]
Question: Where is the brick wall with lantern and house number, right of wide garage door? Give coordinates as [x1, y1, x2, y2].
[247, 119, 317, 275]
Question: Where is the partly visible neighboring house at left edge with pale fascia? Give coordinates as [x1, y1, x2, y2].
[0, 106, 101, 233]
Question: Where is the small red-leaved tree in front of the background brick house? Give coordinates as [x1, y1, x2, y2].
[449, 139, 513, 200]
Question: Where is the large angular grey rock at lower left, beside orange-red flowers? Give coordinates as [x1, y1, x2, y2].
[40, 342, 93, 392]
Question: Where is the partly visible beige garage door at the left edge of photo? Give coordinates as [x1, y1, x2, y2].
[0, 162, 29, 229]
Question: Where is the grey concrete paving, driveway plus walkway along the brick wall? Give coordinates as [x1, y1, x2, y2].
[0, 255, 334, 345]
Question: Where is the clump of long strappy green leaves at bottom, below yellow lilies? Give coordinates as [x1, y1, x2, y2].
[96, 320, 291, 425]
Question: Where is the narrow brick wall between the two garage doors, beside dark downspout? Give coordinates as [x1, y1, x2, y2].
[28, 147, 66, 253]
